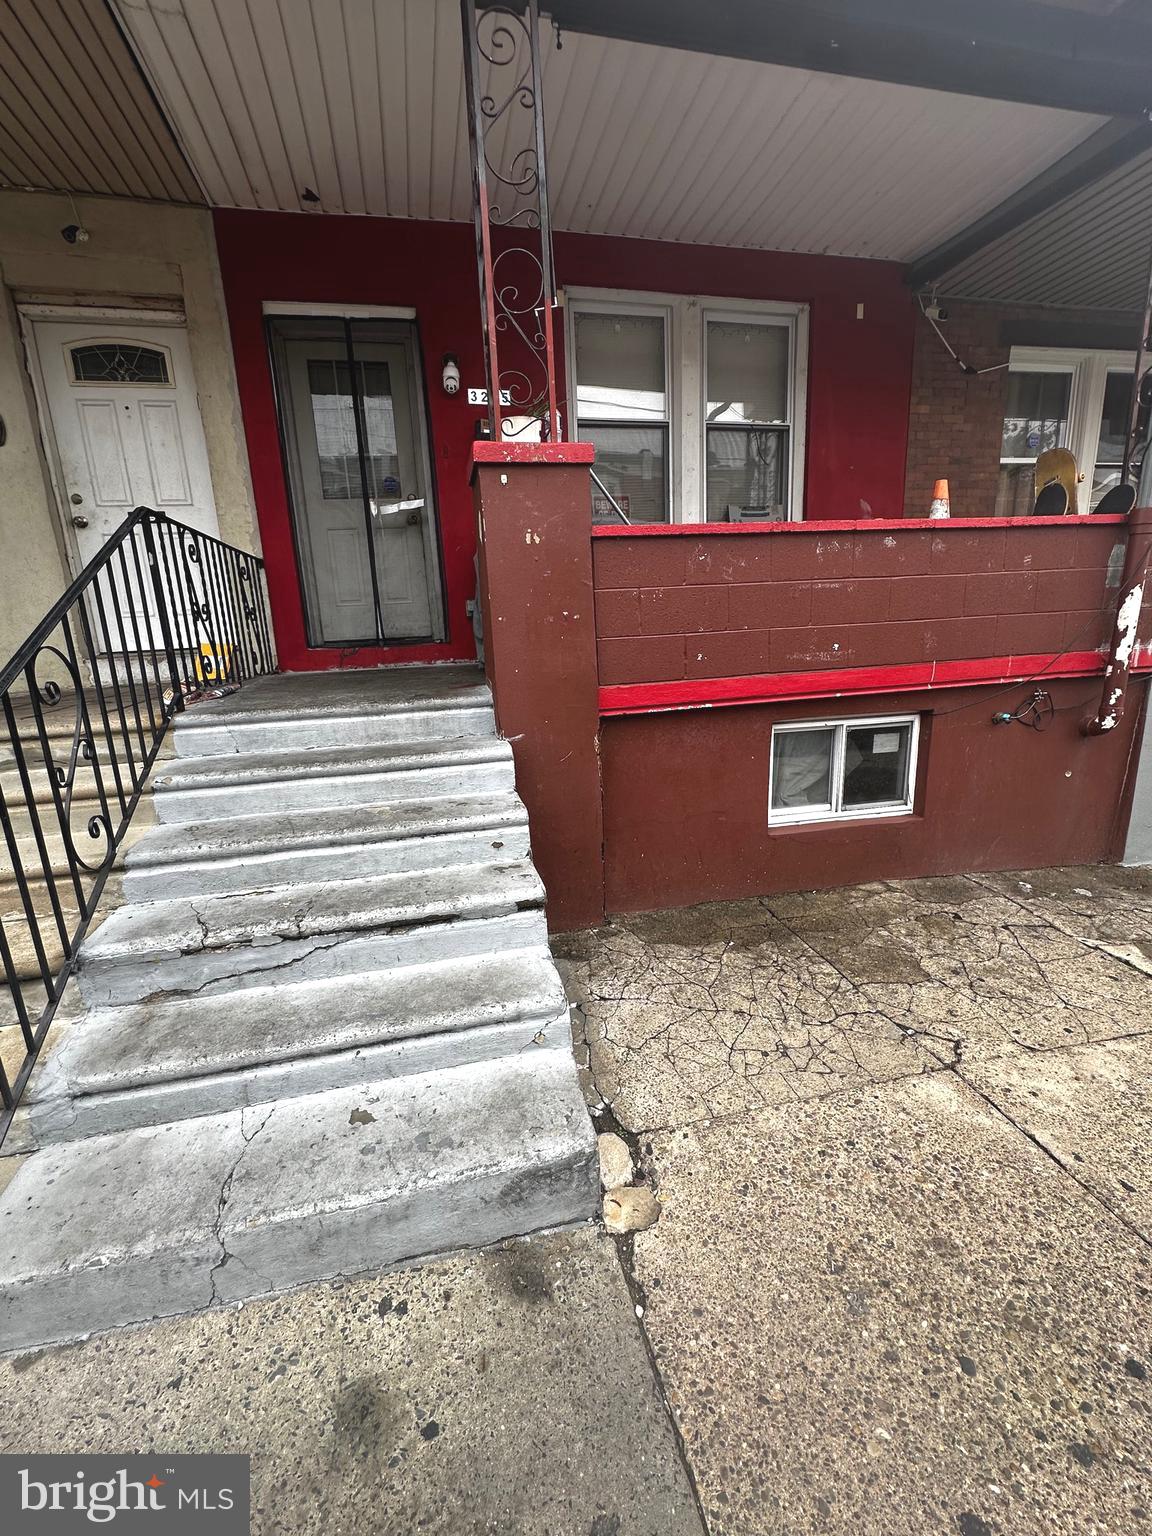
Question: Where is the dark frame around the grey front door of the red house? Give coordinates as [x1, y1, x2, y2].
[261, 300, 450, 654]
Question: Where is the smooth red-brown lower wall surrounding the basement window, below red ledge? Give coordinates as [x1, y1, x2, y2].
[601, 677, 1147, 912]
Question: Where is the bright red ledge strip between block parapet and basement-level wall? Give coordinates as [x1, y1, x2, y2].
[601, 648, 1152, 716]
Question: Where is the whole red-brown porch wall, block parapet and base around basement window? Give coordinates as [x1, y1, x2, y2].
[593, 519, 1152, 912]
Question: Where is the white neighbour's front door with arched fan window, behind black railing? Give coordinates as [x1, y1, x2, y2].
[32, 319, 218, 651]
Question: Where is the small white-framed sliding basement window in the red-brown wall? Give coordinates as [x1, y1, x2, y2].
[768, 714, 920, 826]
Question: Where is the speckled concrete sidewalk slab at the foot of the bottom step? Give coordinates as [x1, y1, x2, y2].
[0, 1229, 702, 1536]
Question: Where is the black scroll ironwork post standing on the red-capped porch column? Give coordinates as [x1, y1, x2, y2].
[461, 0, 561, 441]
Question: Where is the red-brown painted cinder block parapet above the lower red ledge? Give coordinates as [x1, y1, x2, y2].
[593, 518, 1126, 687]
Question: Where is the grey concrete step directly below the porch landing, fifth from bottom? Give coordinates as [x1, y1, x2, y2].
[154, 737, 515, 822]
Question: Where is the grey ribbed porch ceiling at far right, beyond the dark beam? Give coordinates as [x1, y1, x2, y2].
[938, 151, 1152, 312]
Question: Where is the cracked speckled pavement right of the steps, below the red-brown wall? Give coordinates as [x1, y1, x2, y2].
[554, 868, 1152, 1536]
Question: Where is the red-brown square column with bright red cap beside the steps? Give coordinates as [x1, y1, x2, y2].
[472, 441, 604, 932]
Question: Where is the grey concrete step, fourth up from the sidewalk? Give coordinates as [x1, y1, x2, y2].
[124, 794, 528, 902]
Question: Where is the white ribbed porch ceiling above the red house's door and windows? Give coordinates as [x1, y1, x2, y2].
[115, 0, 1103, 261]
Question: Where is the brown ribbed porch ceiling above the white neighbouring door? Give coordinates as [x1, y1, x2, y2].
[0, 0, 204, 203]
